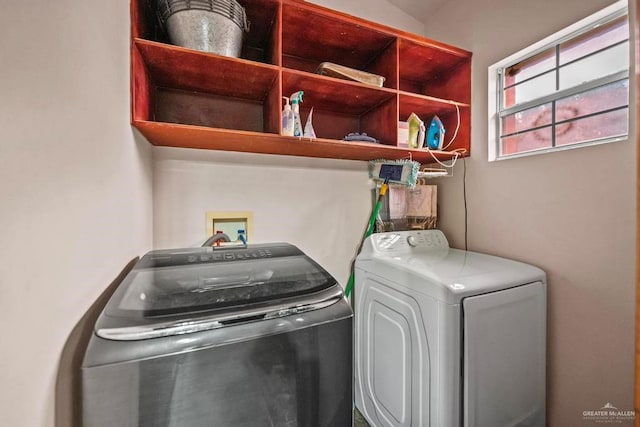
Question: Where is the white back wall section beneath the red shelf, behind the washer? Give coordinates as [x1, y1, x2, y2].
[154, 149, 371, 286]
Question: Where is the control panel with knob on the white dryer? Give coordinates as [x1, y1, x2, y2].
[371, 230, 449, 253]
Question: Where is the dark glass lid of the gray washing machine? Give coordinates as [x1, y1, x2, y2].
[99, 244, 337, 327]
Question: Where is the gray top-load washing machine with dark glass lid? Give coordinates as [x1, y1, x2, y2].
[82, 244, 352, 427]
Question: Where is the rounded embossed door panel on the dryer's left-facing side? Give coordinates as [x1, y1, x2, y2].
[355, 276, 431, 427]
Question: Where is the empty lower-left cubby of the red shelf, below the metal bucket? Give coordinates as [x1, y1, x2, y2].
[135, 39, 280, 133]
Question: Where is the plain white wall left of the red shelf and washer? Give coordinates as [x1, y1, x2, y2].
[0, 0, 152, 426]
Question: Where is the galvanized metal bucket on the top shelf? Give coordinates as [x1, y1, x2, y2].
[158, 0, 249, 58]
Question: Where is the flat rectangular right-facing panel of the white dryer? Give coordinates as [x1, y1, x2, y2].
[463, 282, 546, 427]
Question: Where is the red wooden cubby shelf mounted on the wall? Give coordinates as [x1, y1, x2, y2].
[131, 0, 471, 163]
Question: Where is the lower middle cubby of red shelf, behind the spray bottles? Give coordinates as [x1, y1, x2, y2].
[282, 70, 397, 146]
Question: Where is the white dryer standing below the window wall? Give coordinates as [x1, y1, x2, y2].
[354, 230, 546, 427]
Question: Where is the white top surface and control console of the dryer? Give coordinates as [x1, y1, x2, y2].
[356, 230, 546, 304]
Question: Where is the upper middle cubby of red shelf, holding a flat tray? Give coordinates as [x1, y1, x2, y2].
[282, 2, 397, 89]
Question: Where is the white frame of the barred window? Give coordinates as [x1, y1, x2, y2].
[488, 0, 633, 162]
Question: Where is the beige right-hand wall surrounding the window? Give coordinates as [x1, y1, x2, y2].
[426, 0, 636, 427]
